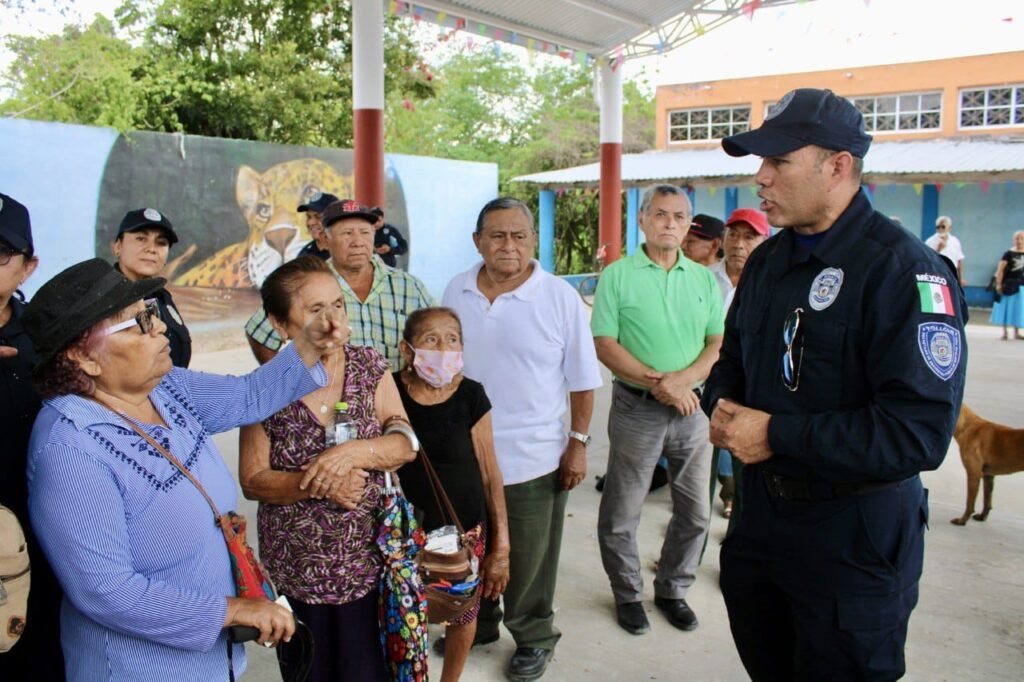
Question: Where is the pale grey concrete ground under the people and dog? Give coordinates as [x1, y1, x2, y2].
[193, 316, 1024, 682]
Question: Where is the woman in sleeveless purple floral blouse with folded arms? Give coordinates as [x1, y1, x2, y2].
[239, 257, 415, 682]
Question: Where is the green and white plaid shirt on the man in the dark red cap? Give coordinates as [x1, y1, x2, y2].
[246, 256, 436, 371]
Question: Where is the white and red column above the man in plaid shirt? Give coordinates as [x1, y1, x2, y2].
[352, 0, 384, 206]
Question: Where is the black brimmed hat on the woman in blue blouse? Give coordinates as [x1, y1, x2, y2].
[22, 258, 167, 364]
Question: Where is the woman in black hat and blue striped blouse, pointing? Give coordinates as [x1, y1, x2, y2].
[23, 258, 342, 682]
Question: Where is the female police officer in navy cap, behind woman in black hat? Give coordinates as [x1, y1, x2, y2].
[114, 208, 191, 367]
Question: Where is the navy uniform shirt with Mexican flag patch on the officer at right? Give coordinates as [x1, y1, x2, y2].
[702, 191, 967, 481]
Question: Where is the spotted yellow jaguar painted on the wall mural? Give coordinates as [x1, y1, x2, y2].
[174, 159, 352, 289]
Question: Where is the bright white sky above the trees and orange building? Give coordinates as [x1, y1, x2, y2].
[0, 0, 1024, 93]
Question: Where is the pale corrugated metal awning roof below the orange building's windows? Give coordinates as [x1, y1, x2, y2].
[512, 136, 1024, 188]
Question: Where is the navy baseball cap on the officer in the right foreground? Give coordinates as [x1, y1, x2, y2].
[722, 88, 871, 159]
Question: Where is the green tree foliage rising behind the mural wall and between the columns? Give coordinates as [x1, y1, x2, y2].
[0, 0, 654, 272]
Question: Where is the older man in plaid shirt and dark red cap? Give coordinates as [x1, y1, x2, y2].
[246, 200, 435, 370]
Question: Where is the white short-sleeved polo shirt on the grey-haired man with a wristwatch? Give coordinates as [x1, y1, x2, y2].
[443, 260, 601, 485]
